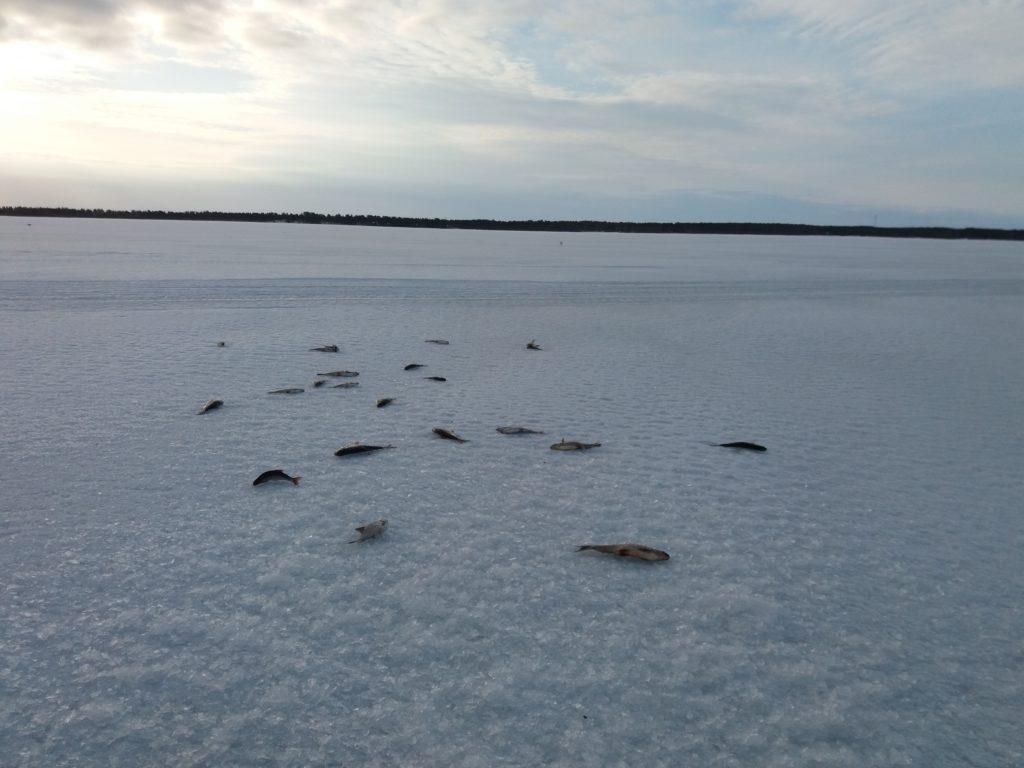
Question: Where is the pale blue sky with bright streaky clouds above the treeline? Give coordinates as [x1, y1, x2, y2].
[0, 0, 1024, 227]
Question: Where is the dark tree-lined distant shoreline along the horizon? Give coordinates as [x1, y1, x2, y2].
[0, 206, 1024, 241]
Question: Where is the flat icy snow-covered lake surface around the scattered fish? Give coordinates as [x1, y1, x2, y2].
[0, 218, 1024, 768]
